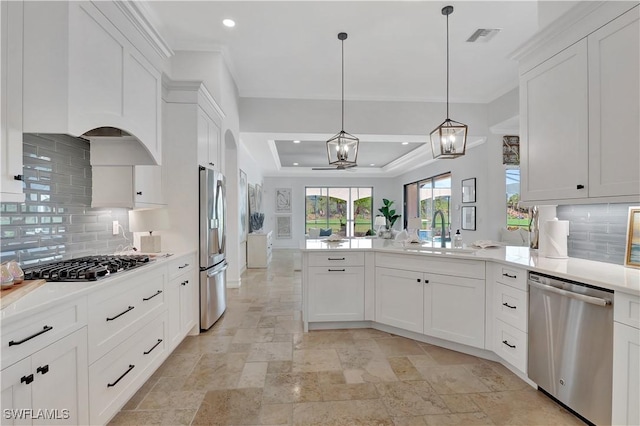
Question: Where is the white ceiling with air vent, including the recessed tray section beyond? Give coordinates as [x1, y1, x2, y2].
[140, 0, 556, 174]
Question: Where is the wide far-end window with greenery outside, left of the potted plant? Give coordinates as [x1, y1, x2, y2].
[305, 187, 374, 237]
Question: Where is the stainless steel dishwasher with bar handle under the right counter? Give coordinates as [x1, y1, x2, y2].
[528, 272, 613, 424]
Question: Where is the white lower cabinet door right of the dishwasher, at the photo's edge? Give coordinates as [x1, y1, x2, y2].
[611, 292, 640, 425]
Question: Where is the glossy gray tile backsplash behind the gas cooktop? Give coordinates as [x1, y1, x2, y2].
[0, 134, 132, 265]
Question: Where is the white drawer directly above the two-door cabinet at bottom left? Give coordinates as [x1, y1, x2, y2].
[0, 297, 87, 368]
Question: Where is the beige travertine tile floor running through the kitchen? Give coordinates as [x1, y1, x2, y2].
[111, 251, 582, 425]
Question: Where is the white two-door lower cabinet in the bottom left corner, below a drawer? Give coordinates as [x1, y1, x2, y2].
[0, 327, 89, 425]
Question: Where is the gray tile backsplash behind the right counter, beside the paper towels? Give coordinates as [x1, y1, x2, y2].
[557, 203, 632, 265]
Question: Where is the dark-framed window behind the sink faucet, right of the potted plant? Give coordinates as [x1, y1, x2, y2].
[404, 173, 451, 243]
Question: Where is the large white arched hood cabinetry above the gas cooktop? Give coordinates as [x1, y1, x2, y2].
[24, 2, 162, 164]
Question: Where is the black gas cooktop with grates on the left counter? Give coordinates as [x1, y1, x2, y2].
[23, 255, 151, 281]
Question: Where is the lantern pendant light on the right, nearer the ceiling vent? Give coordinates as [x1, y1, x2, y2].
[431, 6, 467, 158]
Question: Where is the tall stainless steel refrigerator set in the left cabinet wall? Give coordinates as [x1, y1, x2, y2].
[199, 166, 227, 330]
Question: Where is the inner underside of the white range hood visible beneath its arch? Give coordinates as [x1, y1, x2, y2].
[82, 127, 158, 166]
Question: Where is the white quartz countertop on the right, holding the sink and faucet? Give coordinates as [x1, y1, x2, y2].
[300, 238, 640, 295]
